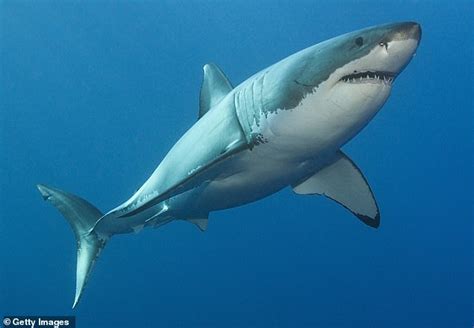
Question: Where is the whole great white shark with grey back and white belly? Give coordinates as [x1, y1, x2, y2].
[37, 22, 421, 308]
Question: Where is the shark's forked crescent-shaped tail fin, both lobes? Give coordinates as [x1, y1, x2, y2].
[37, 184, 108, 309]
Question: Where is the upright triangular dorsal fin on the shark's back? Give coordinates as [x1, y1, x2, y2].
[199, 63, 232, 118]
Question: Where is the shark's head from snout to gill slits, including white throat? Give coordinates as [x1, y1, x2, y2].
[255, 22, 421, 151]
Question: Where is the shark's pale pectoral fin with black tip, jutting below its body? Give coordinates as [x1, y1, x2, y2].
[293, 151, 380, 228]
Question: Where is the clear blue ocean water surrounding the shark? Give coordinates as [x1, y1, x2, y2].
[0, 0, 474, 328]
